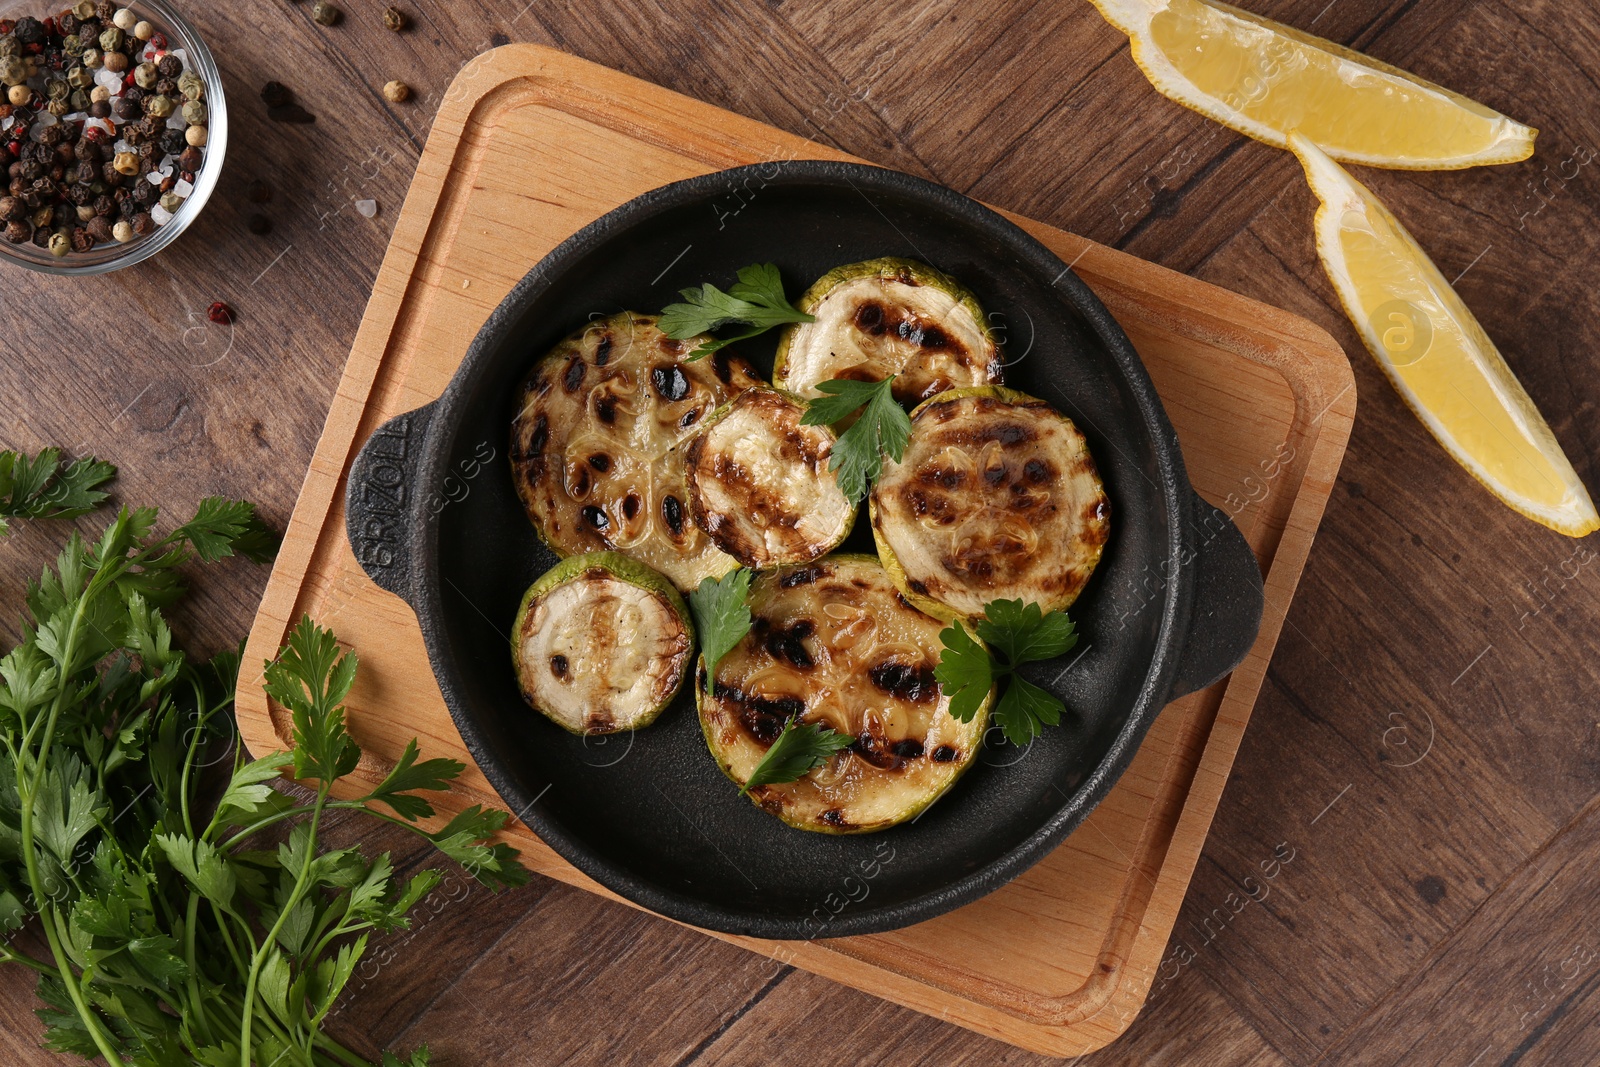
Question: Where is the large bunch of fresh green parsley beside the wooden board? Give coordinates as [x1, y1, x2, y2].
[0, 454, 526, 1067]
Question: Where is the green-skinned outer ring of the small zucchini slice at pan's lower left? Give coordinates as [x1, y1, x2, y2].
[510, 552, 694, 736]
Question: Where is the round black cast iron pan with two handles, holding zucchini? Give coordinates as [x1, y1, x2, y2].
[347, 162, 1261, 937]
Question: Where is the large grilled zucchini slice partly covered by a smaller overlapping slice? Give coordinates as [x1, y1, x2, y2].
[510, 312, 760, 590]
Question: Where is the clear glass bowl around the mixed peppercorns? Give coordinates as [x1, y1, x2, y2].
[0, 0, 227, 274]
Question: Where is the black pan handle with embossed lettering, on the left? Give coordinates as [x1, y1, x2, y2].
[344, 403, 434, 603]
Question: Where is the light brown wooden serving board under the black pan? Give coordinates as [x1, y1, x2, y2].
[238, 45, 1355, 1056]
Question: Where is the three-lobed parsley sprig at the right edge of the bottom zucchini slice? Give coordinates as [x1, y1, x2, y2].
[933, 600, 1078, 745]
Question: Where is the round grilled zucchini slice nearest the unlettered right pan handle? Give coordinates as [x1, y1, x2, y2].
[869, 386, 1110, 619]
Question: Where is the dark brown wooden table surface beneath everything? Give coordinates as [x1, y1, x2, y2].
[0, 0, 1600, 1067]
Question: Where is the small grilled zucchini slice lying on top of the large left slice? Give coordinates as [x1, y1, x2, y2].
[685, 389, 856, 568]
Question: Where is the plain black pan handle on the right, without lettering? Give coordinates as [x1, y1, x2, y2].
[1173, 494, 1262, 699]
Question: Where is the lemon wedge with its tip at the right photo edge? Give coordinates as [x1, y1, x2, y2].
[1288, 133, 1600, 537]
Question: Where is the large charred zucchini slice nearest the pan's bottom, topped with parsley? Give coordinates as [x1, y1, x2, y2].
[694, 555, 989, 833]
